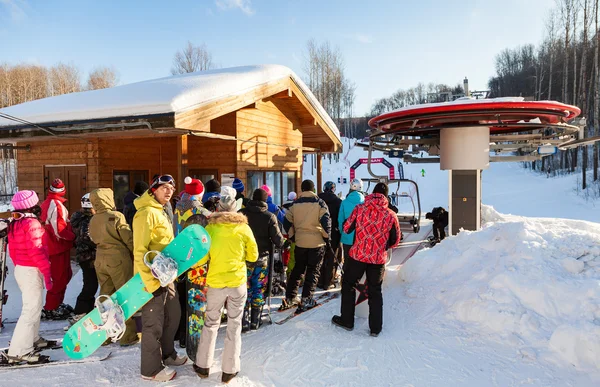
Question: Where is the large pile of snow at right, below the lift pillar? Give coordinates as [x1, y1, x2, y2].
[396, 206, 600, 372]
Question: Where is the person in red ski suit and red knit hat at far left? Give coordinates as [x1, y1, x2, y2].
[40, 179, 75, 320]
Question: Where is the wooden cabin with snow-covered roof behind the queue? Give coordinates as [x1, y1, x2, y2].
[0, 65, 341, 211]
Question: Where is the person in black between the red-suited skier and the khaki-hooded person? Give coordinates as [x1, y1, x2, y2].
[71, 193, 98, 321]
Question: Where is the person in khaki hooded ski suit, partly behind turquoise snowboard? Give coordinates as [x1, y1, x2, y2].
[89, 188, 139, 346]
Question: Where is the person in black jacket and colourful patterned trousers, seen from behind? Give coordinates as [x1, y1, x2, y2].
[240, 188, 285, 332]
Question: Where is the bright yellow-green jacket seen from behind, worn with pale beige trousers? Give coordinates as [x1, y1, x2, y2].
[199, 212, 258, 288]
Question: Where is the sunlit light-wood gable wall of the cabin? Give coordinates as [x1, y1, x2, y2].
[235, 102, 303, 196]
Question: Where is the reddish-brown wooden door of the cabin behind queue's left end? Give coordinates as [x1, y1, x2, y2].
[44, 165, 87, 216]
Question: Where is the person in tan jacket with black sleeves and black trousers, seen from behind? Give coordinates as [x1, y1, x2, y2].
[282, 180, 331, 312]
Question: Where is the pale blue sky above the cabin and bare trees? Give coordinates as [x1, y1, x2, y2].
[0, 0, 555, 115]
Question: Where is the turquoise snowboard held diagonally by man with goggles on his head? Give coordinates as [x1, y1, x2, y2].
[63, 224, 210, 360]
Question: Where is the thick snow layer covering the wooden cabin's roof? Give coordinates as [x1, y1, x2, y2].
[0, 65, 340, 139]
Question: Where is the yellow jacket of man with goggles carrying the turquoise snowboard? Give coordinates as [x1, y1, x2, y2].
[133, 192, 174, 293]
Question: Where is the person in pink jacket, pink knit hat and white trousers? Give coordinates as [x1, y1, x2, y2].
[8, 191, 52, 363]
